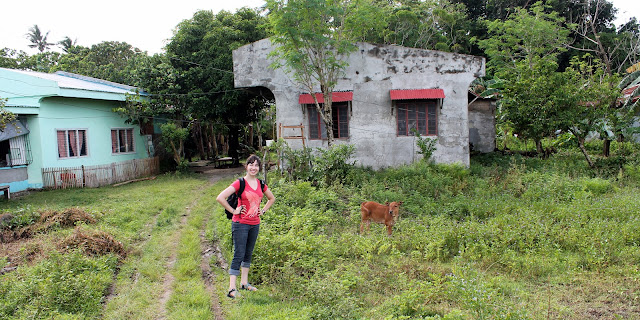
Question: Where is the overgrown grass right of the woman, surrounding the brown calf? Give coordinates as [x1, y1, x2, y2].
[216, 149, 640, 319]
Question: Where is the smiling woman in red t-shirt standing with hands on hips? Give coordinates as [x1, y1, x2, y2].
[216, 155, 276, 298]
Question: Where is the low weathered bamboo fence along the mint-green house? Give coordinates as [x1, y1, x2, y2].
[42, 157, 160, 189]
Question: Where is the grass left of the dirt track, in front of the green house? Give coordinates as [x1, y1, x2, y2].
[0, 175, 206, 319]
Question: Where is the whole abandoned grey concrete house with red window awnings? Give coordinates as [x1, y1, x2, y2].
[233, 39, 495, 169]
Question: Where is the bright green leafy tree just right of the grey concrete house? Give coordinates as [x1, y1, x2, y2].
[479, 3, 568, 153]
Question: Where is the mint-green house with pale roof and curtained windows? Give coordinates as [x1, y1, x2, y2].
[0, 68, 153, 192]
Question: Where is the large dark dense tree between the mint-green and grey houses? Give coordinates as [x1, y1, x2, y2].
[124, 8, 267, 164]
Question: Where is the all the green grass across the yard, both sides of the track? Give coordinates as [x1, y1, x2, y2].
[0, 144, 640, 319]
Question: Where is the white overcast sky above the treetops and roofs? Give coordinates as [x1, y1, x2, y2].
[0, 0, 640, 54]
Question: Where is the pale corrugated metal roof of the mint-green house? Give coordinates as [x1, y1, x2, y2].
[8, 69, 140, 94]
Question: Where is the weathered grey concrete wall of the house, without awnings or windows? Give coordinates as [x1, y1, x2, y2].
[233, 39, 485, 169]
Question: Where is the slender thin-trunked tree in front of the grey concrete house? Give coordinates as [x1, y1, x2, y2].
[267, 0, 375, 146]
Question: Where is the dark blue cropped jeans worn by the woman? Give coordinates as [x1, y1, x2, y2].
[229, 222, 260, 276]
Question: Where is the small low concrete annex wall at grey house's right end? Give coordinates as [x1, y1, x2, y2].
[469, 99, 496, 152]
